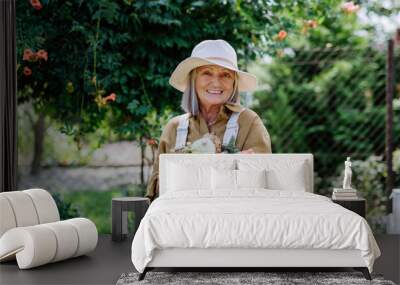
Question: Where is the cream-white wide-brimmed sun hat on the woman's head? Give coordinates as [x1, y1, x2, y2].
[169, 40, 257, 92]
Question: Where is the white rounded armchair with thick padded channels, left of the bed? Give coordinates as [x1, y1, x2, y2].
[0, 189, 98, 269]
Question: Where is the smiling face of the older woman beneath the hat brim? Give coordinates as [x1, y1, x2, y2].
[195, 65, 235, 106]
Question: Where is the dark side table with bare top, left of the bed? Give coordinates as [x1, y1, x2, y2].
[111, 197, 150, 241]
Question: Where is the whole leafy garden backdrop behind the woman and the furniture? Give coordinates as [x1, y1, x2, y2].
[17, 0, 400, 233]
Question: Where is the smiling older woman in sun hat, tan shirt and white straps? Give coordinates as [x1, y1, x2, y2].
[146, 40, 271, 200]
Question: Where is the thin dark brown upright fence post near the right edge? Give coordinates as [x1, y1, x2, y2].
[385, 39, 394, 213]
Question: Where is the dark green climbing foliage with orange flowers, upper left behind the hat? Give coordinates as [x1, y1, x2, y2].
[16, 0, 340, 144]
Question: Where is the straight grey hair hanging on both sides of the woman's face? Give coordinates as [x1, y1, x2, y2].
[181, 69, 239, 116]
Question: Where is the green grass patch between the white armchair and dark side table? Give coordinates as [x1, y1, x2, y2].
[53, 185, 145, 234]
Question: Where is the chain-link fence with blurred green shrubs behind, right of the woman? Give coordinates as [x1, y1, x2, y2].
[254, 43, 400, 194]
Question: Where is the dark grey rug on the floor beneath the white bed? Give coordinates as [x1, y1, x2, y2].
[117, 271, 395, 285]
